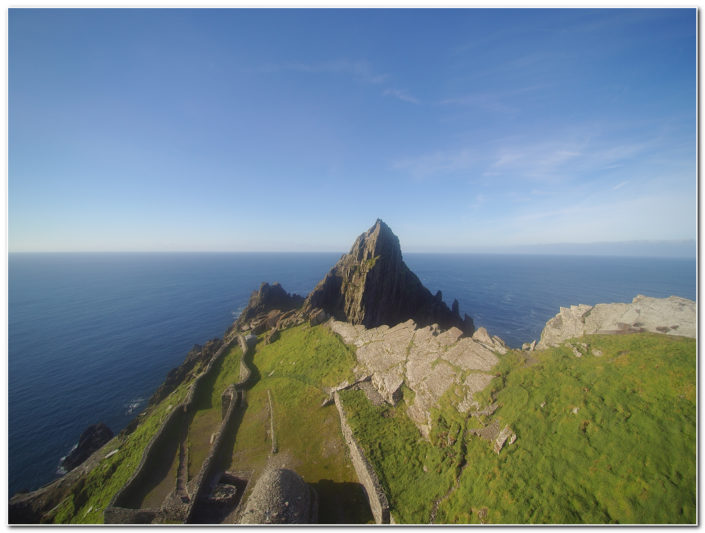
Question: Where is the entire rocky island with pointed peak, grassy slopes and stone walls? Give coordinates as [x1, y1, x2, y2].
[9, 220, 697, 524]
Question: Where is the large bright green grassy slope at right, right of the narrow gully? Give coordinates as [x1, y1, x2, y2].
[439, 334, 696, 524]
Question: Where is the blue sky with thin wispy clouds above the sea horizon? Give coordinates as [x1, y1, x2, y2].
[8, 9, 697, 252]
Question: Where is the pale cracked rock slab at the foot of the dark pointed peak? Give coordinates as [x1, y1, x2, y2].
[329, 320, 503, 437]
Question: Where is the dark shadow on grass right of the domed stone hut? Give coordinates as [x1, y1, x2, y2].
[309, 479, 374, 524]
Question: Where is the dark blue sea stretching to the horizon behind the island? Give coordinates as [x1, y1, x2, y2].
[8, 253, 696, 495]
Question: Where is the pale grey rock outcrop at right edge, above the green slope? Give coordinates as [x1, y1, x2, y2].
[536, 295, 697, 350]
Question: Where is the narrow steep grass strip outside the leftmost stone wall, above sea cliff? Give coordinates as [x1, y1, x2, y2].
[53, 383, 190, 524]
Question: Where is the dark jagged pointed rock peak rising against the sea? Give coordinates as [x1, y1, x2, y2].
[304, 219, 475, 335]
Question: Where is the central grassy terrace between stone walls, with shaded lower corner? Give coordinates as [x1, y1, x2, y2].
[230, 326, 371, 522]
